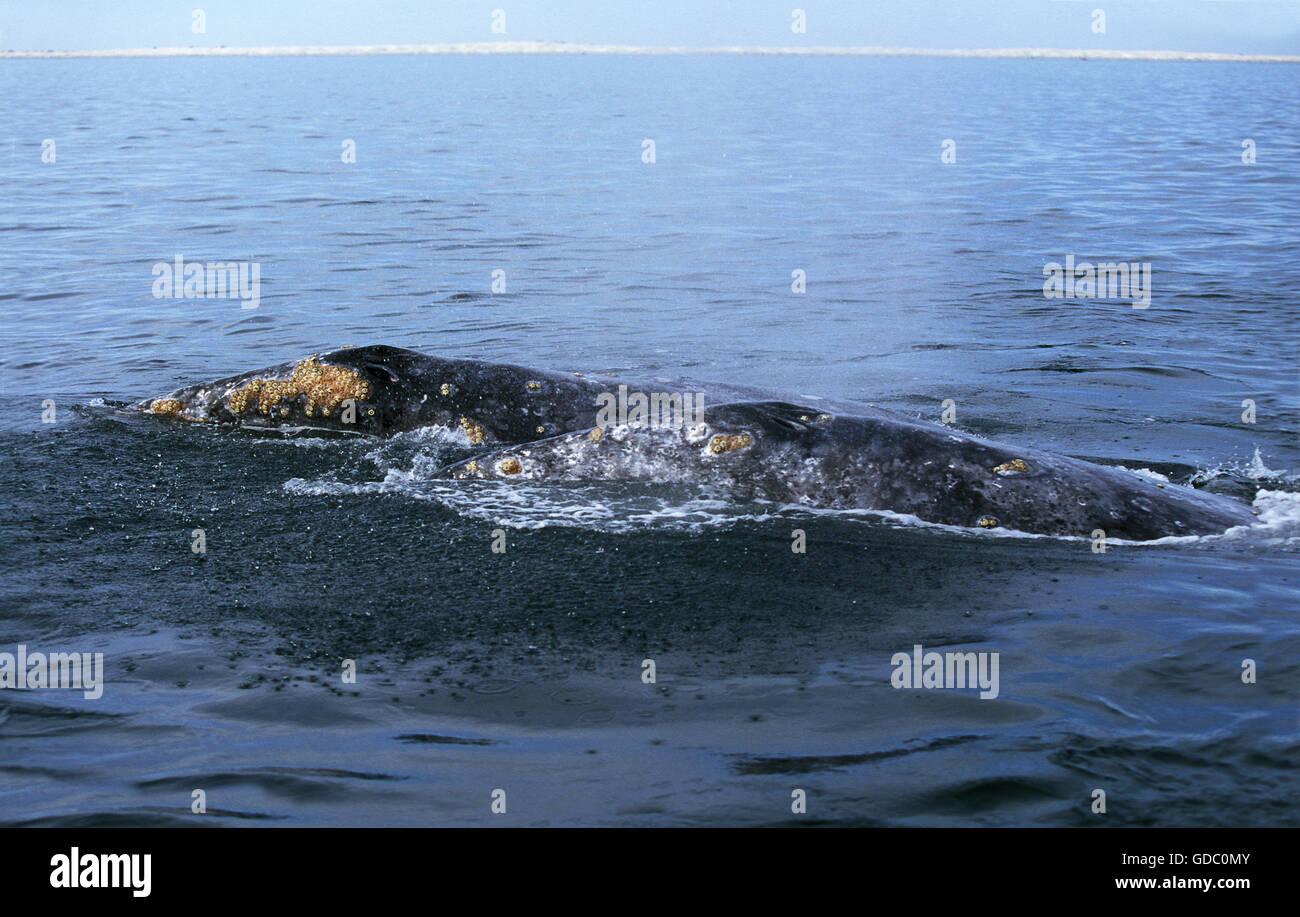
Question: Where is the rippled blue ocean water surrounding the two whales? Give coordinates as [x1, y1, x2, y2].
[0, 56, 1300, 826]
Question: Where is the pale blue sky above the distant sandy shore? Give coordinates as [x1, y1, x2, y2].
[0, 0, 1300, 53]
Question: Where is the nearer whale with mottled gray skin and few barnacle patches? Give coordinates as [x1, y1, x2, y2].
[441, 402, 1253, 541]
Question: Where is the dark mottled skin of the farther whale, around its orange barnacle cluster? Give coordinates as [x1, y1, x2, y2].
[131, 345, 618, 442]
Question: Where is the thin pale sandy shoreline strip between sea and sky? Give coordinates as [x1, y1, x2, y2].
[0, 42, 1300, 64]
